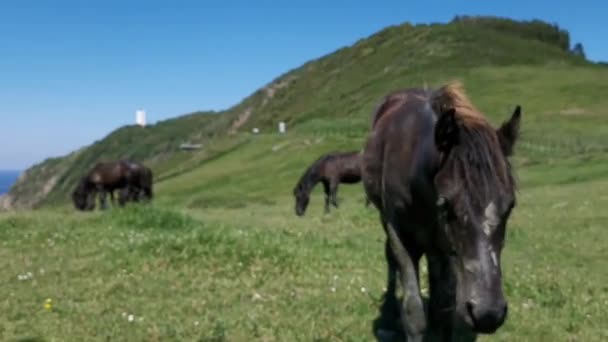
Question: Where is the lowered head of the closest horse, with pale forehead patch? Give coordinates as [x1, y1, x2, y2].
[434, 102, 521, 333]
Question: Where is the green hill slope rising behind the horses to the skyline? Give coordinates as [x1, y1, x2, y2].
[0, 18, 608, 208]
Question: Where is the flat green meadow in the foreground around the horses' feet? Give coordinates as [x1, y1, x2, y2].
[0, 131, 608, 341]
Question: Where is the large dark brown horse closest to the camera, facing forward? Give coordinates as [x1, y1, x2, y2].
[362, 83, 521, 341]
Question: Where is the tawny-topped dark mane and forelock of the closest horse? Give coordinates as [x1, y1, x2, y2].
[430, 82, 514, 205]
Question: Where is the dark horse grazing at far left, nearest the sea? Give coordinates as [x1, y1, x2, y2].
[72, 160, 153, 210]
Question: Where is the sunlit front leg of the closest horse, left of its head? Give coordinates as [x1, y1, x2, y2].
[386, 222, 427, 342]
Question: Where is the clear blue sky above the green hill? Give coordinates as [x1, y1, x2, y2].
[0, 0, 608, 169]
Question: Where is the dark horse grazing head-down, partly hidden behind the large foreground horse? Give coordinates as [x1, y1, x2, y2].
[293, 151, 369, 216]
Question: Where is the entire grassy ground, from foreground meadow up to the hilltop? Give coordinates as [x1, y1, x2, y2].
[0, 18, 608, 341]
